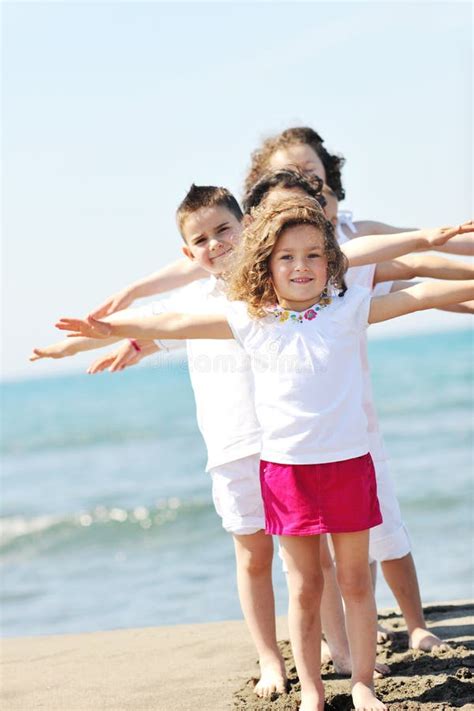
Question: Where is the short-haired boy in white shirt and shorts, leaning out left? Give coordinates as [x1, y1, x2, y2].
[33, 185, 286, 697]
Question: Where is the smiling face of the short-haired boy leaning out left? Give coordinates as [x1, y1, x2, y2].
[182, 205, 243, 276]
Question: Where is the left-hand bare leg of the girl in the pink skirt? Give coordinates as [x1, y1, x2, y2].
[280, 536, 324, 711]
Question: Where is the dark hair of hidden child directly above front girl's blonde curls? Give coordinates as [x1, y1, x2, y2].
[242, 167, 326, 213]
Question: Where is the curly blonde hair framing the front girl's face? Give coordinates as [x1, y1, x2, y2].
[226, 196, 347, 318]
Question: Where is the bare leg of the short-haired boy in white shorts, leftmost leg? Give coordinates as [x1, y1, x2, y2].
[233, 531, 286, 698]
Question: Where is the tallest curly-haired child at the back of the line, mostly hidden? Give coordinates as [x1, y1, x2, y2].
[244, 126, 474, 657]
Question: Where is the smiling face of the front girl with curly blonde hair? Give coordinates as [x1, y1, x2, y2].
[270, 224, 328, 311]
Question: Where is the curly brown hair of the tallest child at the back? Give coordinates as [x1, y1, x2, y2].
[244, 126, 346, 200]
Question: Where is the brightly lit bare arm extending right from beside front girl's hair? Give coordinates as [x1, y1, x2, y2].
[341, 220, 474, 267]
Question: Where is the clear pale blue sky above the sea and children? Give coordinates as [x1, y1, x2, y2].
[2, 1, 472, 377]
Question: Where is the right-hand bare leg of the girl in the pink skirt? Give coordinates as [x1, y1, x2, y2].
[332, 531, 386, 711]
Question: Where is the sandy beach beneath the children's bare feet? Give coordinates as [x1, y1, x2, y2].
[1, 601, 474, 711]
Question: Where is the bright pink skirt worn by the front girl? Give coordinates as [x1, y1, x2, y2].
[260, 454, 382, 536]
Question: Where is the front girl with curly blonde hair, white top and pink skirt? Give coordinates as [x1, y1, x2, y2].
[54, 196, 474, 711]
